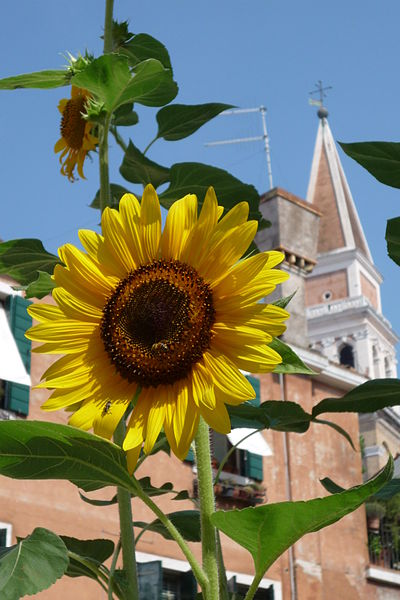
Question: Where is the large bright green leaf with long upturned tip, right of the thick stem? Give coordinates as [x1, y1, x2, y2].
[211, 457, 393, 578]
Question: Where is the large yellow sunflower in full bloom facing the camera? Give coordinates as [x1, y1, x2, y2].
[27, 185, 289, 465]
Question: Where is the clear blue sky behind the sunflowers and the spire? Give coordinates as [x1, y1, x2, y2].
[0, 0, 400, 352]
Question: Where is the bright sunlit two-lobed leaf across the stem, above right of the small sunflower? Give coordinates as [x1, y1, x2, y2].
[72, 54, 178, 113]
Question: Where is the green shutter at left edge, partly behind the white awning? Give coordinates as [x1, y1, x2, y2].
[5, 296, 32, 415]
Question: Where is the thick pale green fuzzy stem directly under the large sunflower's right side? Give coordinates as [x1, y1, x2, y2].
[195, 417, 219, 600]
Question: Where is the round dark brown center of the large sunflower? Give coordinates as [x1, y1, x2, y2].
[101, 260, 215, 387]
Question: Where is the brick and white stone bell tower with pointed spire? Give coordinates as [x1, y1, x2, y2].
[306, 111, 398, 378]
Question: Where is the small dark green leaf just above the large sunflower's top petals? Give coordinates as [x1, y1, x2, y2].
[119, 141, 169, 188]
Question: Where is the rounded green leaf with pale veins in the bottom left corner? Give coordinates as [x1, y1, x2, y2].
[0, 527, 68, 600]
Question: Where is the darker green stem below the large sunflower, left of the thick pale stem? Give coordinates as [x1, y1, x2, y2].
[114, 419, 139, 600]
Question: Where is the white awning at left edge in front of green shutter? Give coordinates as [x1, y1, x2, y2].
[0, 304, 31, 385]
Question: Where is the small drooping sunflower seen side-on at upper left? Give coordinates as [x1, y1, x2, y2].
[54, 85, 98, 181]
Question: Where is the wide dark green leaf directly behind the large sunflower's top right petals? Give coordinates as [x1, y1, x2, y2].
[160, 162, 262, 221]
